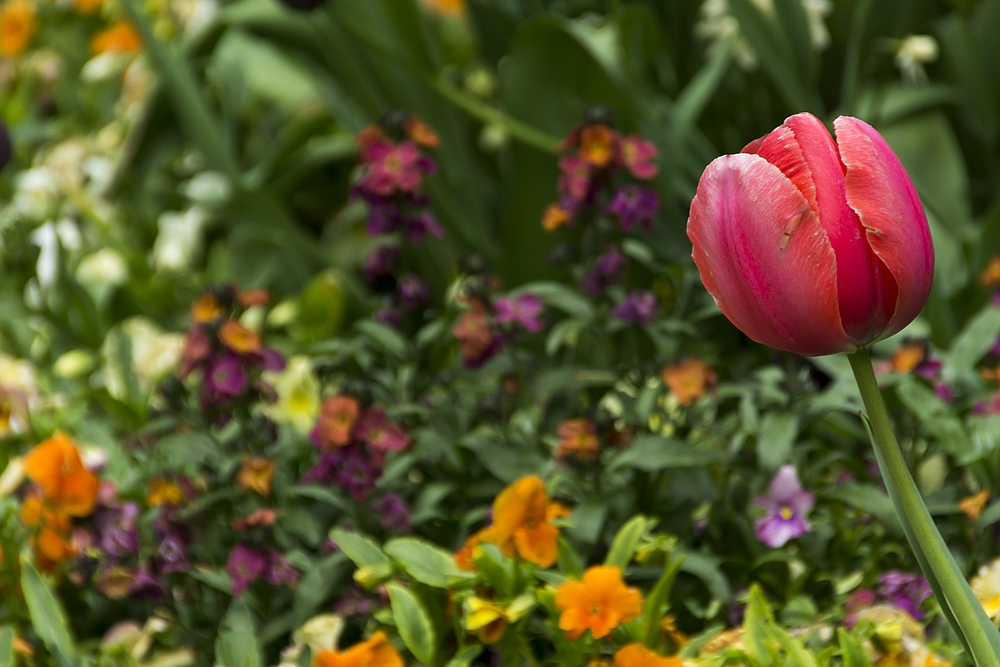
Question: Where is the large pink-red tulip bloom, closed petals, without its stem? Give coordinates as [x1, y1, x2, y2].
[687, 113, 934, 355]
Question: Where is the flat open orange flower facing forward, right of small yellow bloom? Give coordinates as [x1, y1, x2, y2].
[556, 565, 642, 639]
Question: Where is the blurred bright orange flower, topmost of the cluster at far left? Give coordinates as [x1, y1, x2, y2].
[24, 432, 98, 517]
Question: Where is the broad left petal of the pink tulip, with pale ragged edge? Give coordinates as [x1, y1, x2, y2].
[687, 153, 853, 355]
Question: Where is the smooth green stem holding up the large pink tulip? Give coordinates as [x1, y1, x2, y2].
[847, 349, 1000, 667]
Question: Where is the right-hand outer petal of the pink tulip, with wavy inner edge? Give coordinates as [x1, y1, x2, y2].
[833, 116, 934, 338]
